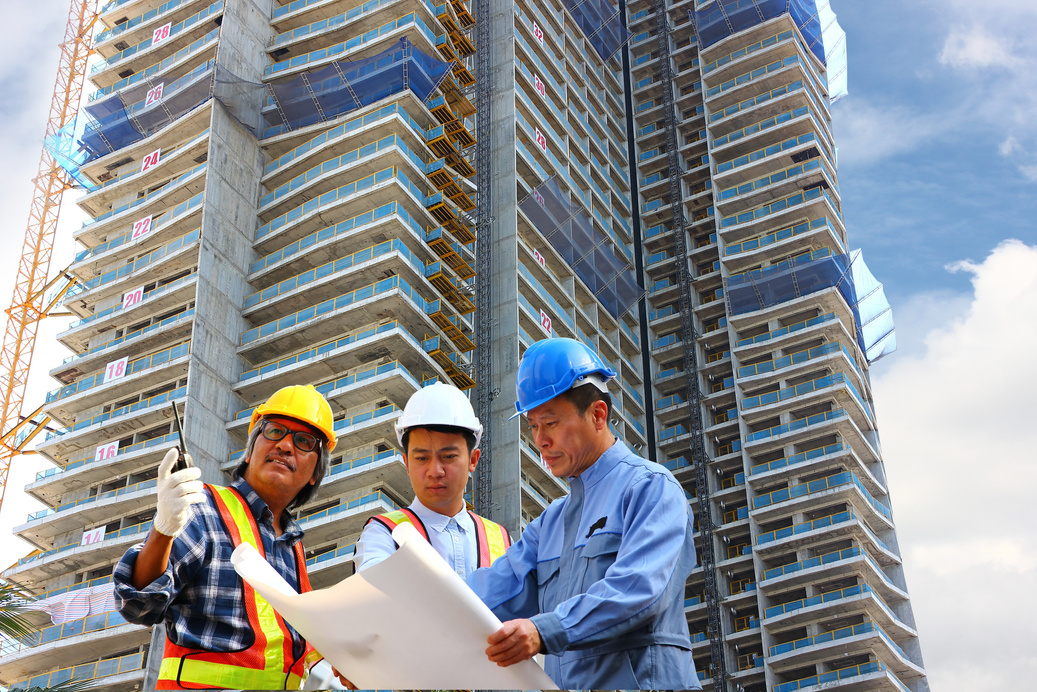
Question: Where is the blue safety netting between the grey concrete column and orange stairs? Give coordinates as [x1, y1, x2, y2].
[263, 36, 453, 137]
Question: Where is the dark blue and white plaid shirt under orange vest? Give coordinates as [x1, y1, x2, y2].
[113, 478, 305, 658]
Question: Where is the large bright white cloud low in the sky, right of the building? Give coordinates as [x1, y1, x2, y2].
[874, 241, 1037, 692]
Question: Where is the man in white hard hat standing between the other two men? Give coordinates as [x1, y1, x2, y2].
[354, 383, 511, 579]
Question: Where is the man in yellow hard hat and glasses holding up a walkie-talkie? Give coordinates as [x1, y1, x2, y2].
[113, 386, 335, 690]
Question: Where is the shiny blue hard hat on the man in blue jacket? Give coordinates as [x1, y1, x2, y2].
[511, 337, 616, 418]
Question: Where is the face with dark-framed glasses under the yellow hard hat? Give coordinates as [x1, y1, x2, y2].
[245, 416, 320, 506]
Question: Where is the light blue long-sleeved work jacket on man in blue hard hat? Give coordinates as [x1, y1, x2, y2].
[468, 441, 701, 690]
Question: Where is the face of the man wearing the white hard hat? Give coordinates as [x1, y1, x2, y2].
[403, 427, 479, 517]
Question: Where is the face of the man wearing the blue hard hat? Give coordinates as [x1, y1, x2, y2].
[526, 396, 607, 478]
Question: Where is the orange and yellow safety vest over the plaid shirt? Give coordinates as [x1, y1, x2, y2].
[156, 485, 320, 690]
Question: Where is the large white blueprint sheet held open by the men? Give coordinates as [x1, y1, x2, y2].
[231, 523, 557, 690]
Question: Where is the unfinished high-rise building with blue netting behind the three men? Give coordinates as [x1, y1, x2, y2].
[0, 0, 928, 692]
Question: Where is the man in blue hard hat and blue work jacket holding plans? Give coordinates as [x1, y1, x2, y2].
[468, 338, 701, 690]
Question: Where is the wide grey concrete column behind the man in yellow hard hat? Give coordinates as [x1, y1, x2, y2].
[144, 0, 272, 690]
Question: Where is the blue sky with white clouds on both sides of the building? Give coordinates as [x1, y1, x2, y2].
[0, 0, 1037, 692]
